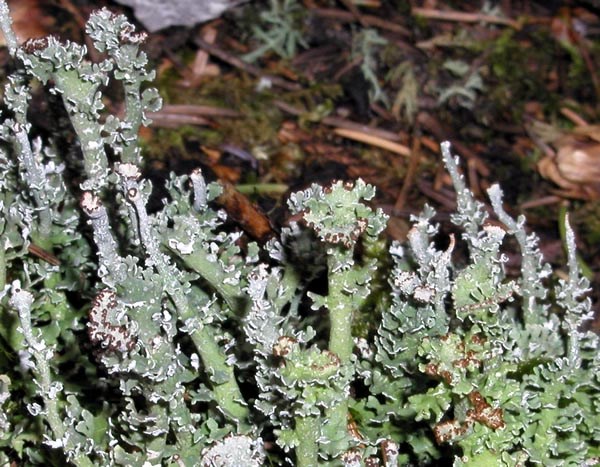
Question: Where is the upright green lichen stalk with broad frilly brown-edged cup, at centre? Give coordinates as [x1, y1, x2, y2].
[289, 180, 387, 455]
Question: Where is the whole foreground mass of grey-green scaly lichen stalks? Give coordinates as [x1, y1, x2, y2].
[0, 1, 600, 466]
